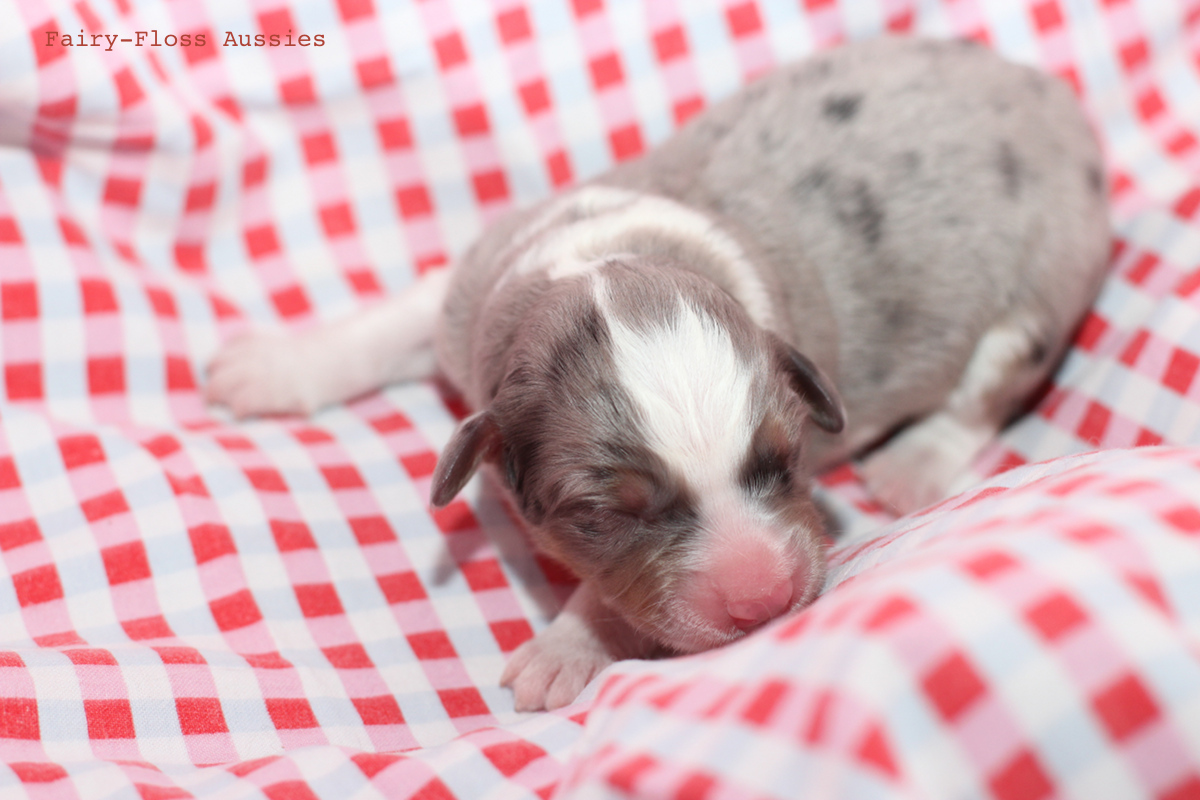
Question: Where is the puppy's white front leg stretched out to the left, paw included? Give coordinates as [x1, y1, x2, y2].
[204, 270, 449, 417]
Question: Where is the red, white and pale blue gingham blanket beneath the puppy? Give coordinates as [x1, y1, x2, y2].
[0, 0, 1200, 800]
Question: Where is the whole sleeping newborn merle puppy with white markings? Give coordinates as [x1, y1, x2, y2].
[208, 38, 1109, 709]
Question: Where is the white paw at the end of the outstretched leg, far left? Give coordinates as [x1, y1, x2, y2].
[204, 331, 322, 417]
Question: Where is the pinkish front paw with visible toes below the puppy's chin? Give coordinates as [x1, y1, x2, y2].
[500, 616, 613, 711]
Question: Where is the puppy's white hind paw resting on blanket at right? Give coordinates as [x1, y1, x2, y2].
[860, 414, 992, 515]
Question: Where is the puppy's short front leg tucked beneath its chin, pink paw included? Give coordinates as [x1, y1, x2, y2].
[500, 582, 655, 711]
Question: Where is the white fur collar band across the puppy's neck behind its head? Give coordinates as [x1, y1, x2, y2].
[509, 186, 773, 327]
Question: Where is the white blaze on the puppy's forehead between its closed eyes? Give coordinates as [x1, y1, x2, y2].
[593, 279, 755, 489]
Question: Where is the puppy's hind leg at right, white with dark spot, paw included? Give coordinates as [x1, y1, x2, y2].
[862, 319, 1054, 513]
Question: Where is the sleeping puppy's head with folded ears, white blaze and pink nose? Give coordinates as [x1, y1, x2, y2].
[432, 263, 844, 652]
